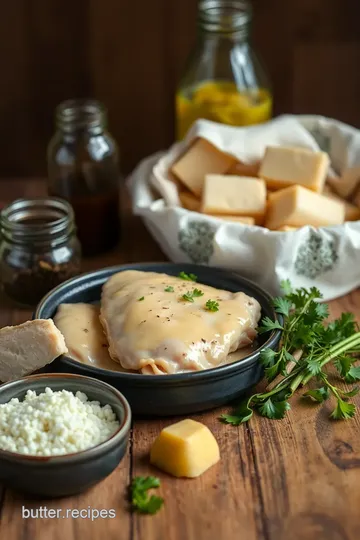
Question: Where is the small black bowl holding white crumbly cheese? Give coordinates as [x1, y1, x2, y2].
[0, 373, 131, 497]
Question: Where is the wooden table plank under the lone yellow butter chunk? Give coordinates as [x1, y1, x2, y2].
[132, 410, 266, 540]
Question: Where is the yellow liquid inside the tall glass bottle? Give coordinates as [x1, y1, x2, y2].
[176, 81, 272, 140]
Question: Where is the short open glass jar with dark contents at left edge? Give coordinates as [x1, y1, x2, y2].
[0, 198, 81, 306]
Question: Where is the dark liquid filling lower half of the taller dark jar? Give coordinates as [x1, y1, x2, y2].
[51, 189, 120, 257]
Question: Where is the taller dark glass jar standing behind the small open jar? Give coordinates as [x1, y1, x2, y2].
[48, 99, 120, 256]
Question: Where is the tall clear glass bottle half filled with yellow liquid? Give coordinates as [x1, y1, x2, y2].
[176, 0, 272, 139]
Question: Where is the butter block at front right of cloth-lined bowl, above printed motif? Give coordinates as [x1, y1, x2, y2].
[266, 185, 345, 229]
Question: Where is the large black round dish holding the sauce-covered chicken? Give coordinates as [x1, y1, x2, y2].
[34, 263, 281, 416]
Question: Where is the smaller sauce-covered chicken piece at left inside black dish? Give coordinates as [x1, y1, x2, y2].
[54, 302, 129, 371]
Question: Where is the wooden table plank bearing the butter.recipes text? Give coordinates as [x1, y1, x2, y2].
[0, 460, 132, 540]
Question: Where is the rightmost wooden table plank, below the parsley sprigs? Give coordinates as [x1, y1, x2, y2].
[245, 291, 360, 540]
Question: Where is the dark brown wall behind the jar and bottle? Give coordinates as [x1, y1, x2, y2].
[0, 0, 360, 177]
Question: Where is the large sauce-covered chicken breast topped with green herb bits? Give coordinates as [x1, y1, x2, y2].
[100, 270, 260, 374]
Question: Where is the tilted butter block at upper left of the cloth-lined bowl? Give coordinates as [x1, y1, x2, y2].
[170, 138, 235, 197]
